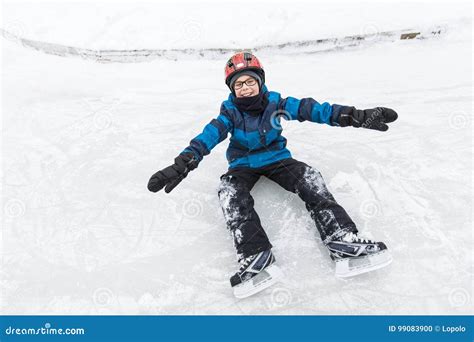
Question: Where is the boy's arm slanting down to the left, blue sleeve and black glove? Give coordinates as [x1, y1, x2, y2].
[148, 106, 233, 193]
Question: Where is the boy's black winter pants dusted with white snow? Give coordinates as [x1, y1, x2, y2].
[218, 158, 357, 260]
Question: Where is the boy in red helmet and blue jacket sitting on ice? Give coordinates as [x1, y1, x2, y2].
[148, 52, 398, 298]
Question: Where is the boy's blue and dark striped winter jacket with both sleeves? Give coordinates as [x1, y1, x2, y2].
[181, 85, 343, 169]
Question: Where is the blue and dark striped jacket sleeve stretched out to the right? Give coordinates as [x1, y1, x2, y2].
[278, 96, 342, 126]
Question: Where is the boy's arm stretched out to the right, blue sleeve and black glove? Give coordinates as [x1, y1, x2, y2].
[278, 97, 398, 131]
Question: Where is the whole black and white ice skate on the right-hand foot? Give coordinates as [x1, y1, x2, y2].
[326, 233, 392, 278]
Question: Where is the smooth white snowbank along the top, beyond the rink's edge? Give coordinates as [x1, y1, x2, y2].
[2, 0, 471, 49]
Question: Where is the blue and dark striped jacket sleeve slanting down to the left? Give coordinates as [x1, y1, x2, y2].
[181, 108, 233, 161]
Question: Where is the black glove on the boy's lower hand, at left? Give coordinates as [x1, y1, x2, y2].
[148, 153, 199, 193]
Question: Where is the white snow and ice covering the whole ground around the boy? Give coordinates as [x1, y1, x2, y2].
[0, 3, 473, 314]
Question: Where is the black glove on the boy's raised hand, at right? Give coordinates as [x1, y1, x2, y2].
[336, 107, 398, 131]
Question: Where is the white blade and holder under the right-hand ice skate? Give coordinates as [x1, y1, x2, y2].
[336, 250, 393, 278]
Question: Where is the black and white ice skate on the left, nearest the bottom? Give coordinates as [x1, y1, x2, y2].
[230, 250, 283, 298]
